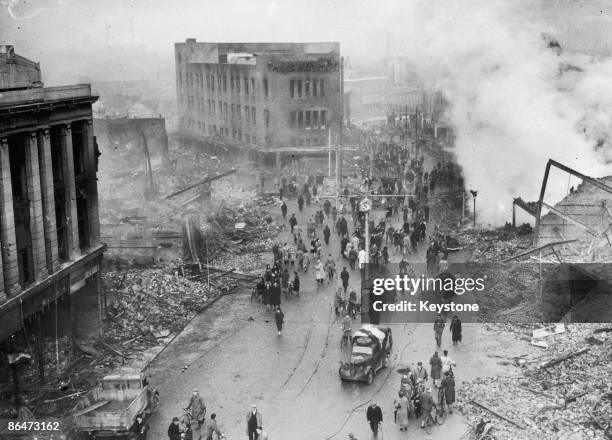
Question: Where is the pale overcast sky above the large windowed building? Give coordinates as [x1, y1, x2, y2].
[0, 0, 612, 83]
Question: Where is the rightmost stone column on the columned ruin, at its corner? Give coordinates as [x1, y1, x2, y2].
[83, 120, 100, 247]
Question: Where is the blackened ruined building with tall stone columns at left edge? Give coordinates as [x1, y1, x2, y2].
[0, 46, 104, 375]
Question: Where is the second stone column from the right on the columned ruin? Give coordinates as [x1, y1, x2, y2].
[62, 124, 81, 260]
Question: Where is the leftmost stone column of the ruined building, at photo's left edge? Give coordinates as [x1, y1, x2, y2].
[0, 138, 21, 296]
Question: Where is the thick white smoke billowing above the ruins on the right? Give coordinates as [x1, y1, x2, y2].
[396, 1, 612, 224]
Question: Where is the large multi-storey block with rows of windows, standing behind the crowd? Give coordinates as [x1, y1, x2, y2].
[175, 39, 342, 162]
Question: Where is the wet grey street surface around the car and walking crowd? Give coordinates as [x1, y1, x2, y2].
[148, 158, 519, 440]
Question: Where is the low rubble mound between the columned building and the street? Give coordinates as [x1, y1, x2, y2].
[102, 269, 225, 345]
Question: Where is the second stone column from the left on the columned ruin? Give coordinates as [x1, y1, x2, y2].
[24, 132, 49, 281]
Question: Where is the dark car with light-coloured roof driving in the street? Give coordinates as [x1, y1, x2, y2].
[338, 324, 393, 385]
